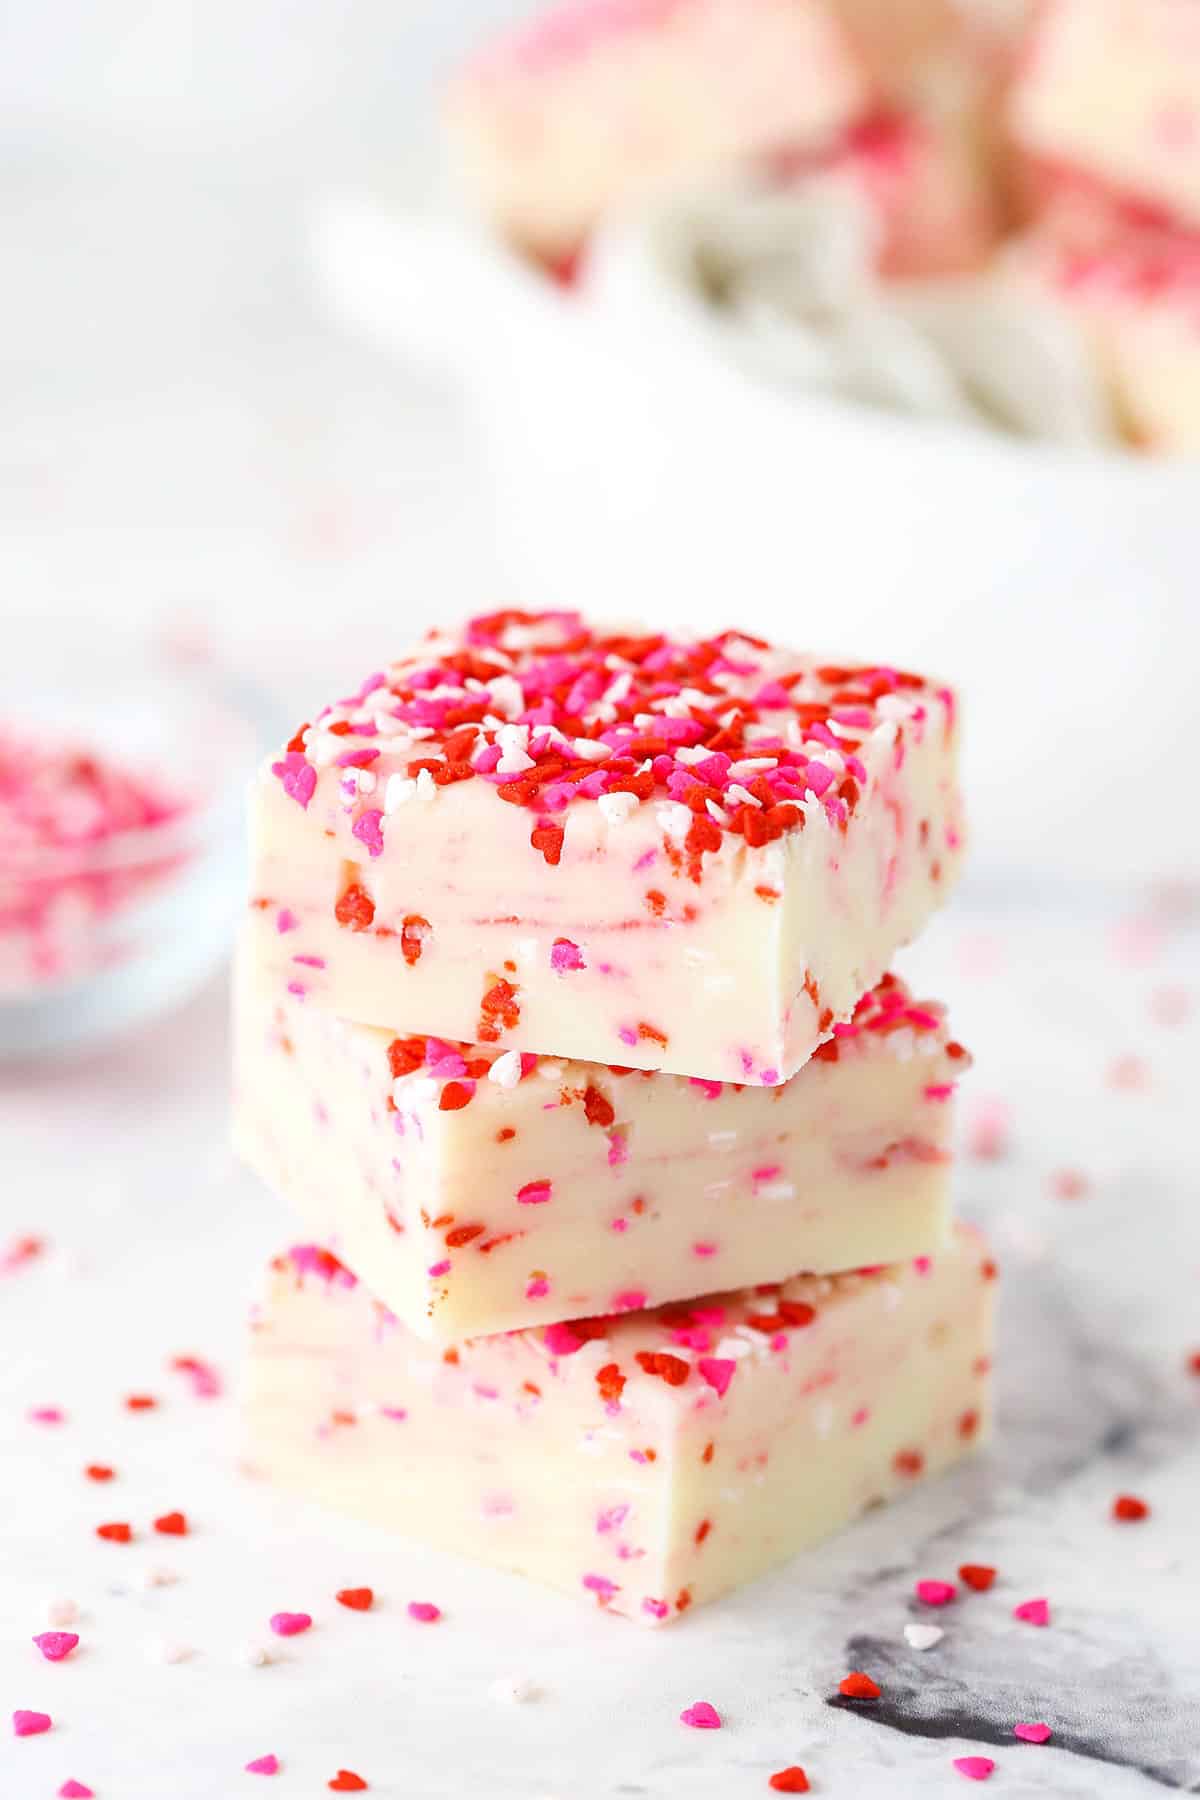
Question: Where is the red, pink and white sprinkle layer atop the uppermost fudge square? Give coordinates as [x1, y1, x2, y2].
[272, 610, 954, 871]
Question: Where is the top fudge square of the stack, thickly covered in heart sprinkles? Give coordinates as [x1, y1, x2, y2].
[250, 612, 963, 1085]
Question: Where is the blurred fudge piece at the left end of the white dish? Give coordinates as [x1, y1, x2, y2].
[444, 0, 867, 261]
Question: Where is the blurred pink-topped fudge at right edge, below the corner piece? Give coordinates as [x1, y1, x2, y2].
[1013, 232, 1200, 457]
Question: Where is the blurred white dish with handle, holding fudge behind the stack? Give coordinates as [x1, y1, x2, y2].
[315, 196, 1200, 882]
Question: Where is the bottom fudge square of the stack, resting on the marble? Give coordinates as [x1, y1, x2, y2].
[245, 1228, 995, 1625]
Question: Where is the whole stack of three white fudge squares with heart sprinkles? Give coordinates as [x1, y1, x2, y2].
[236, 612, 995, 1624]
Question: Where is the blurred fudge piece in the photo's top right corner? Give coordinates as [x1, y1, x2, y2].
[1011, 0, 1200, 227]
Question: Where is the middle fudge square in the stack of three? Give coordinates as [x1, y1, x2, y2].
[234, 959, 970, 1341]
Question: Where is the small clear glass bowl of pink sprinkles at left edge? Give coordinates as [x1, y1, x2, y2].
[0, 621, 268, 1062]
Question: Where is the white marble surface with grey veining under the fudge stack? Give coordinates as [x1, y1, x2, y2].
[0, 895, 1200, 1800]
